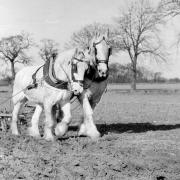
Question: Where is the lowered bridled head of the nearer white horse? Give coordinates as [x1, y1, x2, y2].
[71, 49, 89, 95]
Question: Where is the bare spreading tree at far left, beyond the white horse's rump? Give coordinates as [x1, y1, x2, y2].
[0, 33, 33, 80]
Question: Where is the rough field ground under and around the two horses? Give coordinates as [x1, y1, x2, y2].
[0, 86, 180, 180]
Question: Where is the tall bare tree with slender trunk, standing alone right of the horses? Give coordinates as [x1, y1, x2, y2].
[115, 0, 165, 90]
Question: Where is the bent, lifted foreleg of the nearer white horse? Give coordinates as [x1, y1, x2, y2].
[55, 102, 71, 136]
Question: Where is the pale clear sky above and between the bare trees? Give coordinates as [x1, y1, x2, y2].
[0, 0, 180, 78]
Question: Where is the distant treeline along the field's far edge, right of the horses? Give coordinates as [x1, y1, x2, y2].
[108, 63, 180, 83]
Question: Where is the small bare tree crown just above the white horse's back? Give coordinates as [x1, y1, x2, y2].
[39, 39, 58, 61]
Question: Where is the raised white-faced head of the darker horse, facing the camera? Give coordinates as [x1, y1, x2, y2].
[90, 32, 111, 78]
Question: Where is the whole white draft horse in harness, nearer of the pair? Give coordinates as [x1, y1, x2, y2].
[11, 49, 88, 140]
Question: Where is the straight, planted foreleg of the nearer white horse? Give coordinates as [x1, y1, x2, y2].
[44, 103, 54, 141]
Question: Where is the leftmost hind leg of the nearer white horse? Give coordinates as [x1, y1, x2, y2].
[11, 97, 27, 135]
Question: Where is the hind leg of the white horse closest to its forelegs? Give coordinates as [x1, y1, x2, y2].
[28, 104, 43, 138]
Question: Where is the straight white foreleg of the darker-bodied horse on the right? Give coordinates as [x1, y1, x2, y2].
[78, 95, 100, 140]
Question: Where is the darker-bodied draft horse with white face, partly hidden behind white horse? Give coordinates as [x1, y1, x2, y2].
[56, 32, 111, 140]
